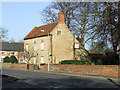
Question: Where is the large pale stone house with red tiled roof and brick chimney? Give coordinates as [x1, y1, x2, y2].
[24, 12, 88, 65]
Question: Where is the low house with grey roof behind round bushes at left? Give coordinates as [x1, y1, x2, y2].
[0, 38, 24, 62]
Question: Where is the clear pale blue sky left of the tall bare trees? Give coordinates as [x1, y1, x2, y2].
[1, 2, 51, 41]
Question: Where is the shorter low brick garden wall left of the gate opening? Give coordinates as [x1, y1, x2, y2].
[2, 63, 34, 70]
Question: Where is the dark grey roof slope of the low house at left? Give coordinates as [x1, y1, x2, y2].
[0, 42, 24, 52]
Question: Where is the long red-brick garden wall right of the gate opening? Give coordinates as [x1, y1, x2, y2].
[40, 65, 120, 77]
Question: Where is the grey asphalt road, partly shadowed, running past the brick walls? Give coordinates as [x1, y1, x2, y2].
[2, 69, 120, 88]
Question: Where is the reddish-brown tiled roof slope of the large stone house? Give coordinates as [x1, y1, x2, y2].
[24, 22, 58, 40]
